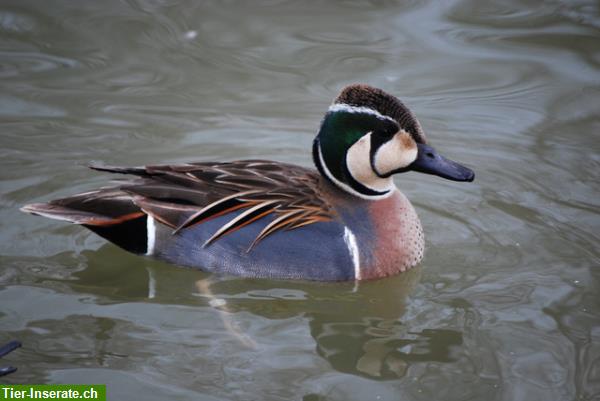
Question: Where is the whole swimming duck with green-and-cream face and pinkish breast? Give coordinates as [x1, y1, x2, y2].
[21, 84, 475, 281]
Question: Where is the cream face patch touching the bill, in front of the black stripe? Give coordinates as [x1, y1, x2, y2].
[373, 131, 417, 175]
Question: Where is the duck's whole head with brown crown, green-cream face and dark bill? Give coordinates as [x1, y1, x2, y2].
[313, 84, 475, 199]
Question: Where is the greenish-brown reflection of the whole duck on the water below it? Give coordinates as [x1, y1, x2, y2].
[17, 244, 463, 380]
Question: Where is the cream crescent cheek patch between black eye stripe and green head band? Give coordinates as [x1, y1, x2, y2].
[346, 132, 395, 192]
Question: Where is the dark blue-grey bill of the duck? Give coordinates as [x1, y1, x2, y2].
[408, 143, 475, 182]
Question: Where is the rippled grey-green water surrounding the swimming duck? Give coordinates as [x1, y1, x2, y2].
[0, 0, 600, 401]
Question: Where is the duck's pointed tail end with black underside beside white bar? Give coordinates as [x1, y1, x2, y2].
[21, 189, 148, 253]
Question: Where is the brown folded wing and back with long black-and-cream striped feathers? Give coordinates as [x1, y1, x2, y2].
[85, 160, 334, 250]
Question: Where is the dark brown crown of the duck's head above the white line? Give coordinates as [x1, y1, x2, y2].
[334, 84, 427, 143]
